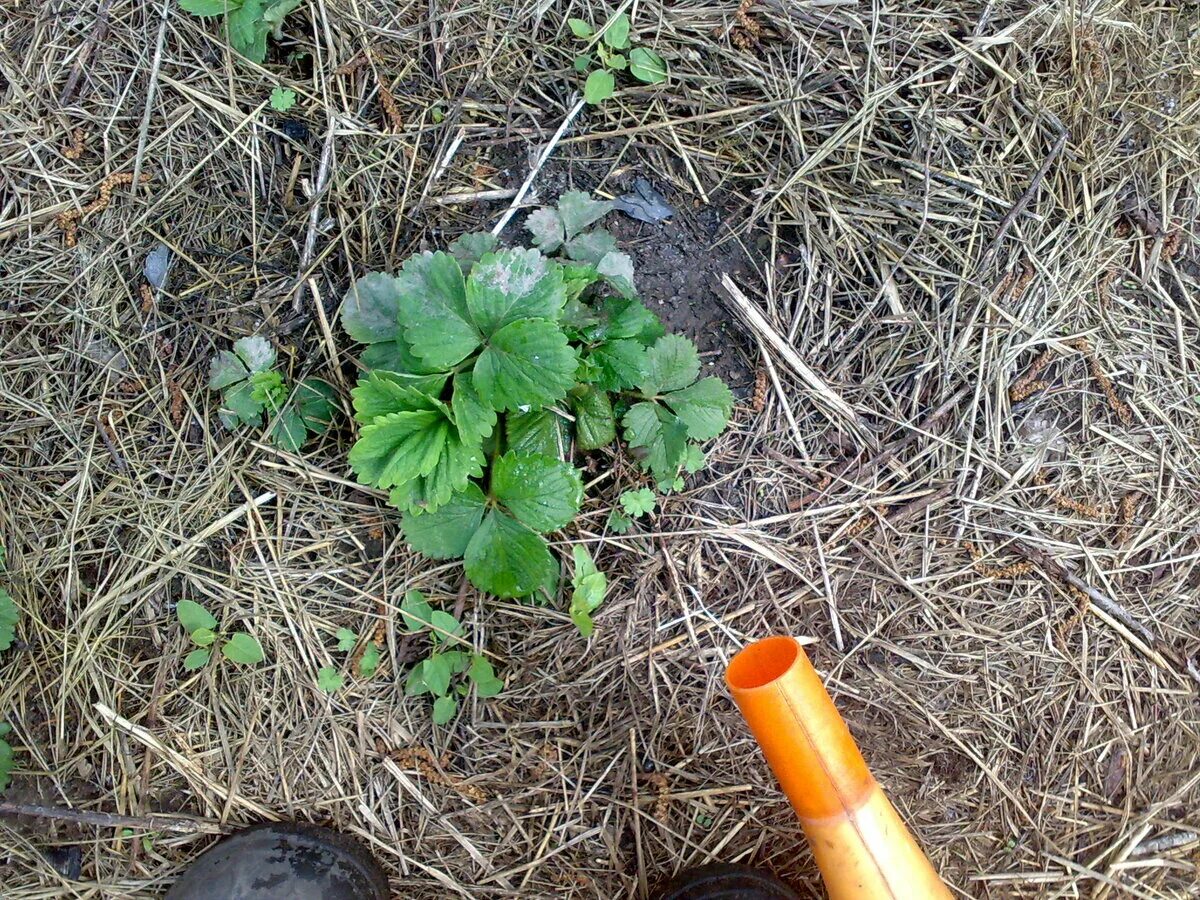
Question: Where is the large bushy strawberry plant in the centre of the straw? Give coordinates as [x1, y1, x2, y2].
[341, 192, 733, 614]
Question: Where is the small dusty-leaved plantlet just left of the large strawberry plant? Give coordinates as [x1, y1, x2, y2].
[209, 337, 337, 452]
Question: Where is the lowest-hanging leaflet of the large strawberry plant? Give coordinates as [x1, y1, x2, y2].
[464, 510, 558, 598]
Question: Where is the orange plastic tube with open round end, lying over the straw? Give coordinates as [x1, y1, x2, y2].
[725, 637, 950, 900]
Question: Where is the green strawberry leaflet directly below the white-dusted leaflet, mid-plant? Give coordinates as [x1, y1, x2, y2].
[473, 319, 578, 410]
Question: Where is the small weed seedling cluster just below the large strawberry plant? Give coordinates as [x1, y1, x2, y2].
[400, 590, 504, 725]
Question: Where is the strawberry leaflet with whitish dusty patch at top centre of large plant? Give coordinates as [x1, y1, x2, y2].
[467, 248, 566, 336]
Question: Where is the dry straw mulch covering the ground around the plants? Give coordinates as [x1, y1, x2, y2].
[0, 0, 1200, 898]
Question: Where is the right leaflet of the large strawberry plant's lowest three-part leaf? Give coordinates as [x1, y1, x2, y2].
[492, 451, 583, 532]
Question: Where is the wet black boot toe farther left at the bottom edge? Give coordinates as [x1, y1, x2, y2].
[167, 822, 388, 900]
